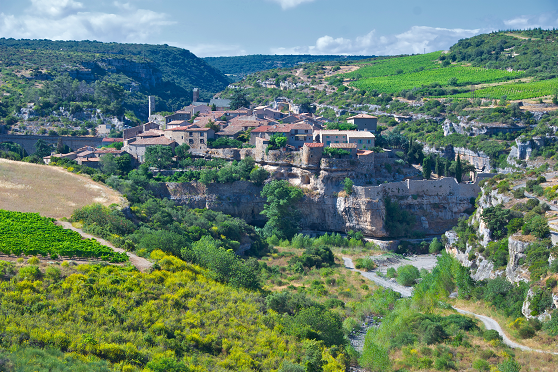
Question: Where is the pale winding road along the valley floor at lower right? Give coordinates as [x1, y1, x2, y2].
[343, 257, 558, 355]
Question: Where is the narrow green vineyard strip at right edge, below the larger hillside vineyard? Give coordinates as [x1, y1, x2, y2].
[452, 78, 558, 100]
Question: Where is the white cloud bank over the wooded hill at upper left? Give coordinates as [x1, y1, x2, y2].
[0, 0, 173, 42]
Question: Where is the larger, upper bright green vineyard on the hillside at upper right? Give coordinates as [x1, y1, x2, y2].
[352, 65, 523, 94]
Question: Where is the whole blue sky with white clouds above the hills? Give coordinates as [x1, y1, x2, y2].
[0, 0, 558, 57]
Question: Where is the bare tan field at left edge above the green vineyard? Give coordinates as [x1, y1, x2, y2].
[0, 159, 125, 218]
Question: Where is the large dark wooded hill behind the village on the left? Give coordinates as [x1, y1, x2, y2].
[0, 38, 229, 119]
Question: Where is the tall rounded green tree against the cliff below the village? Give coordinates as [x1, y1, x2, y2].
[261, 180, 304, 239]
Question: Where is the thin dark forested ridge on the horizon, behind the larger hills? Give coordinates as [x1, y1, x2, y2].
[204, 54, 375, 81]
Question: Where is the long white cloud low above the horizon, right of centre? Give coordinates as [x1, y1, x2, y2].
[271, 26, 484, 55]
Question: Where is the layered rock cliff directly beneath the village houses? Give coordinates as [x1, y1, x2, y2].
[158, 176, 479, 237]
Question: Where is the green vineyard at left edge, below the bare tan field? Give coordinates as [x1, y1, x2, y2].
[0, 209, 128, 263]
